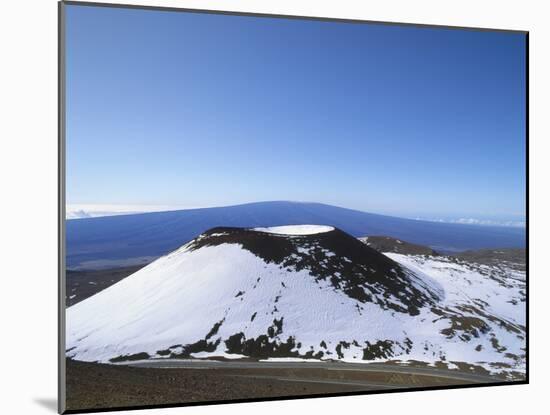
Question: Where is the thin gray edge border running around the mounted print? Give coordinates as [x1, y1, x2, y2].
[57, 0, 530, 414]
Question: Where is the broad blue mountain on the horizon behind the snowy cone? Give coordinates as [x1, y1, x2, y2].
[66, 202, 525, 269]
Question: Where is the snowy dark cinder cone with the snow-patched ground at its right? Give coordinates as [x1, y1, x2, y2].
[66, 225, 525, 376]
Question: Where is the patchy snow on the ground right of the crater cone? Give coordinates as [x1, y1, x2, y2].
[385, 253, 526, 372]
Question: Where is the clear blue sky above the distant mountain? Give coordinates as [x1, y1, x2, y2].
[66, 6, 526, 220]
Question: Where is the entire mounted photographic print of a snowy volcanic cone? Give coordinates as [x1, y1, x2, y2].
[59, 2, 528, 412]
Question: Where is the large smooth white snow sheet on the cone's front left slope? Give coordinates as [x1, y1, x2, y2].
[66, 244, 408, 361]
